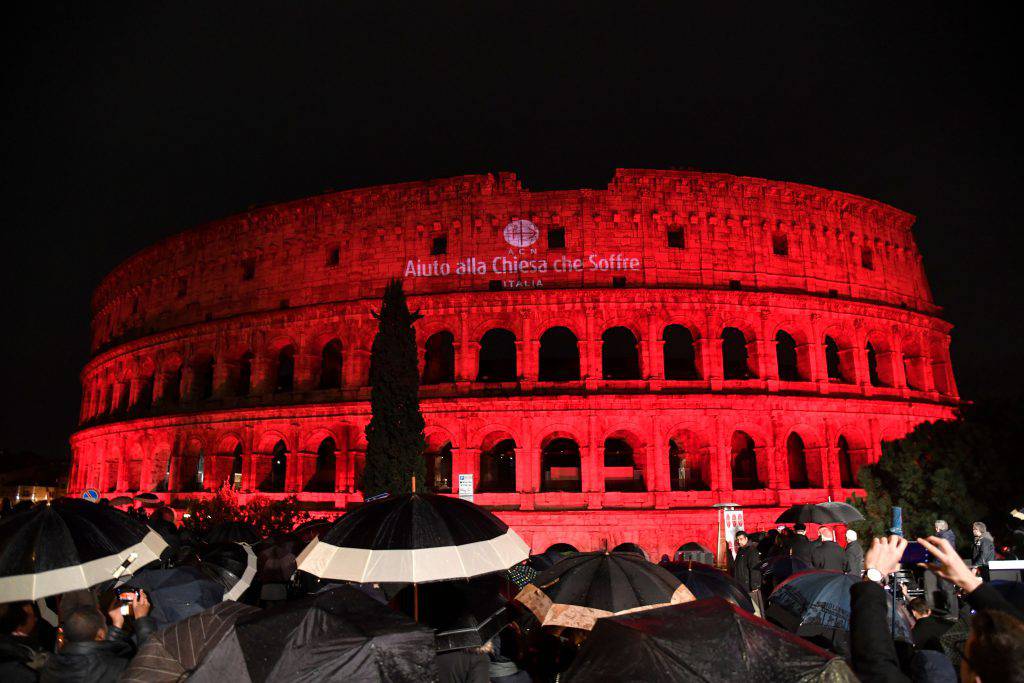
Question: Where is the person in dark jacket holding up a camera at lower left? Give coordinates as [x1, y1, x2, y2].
[40, 591, 156, 683]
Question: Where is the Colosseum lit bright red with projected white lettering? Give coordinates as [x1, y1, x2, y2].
[71, 169, 958, 557]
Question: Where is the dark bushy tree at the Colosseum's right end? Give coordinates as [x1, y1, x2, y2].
[850, 403, 1024, 551]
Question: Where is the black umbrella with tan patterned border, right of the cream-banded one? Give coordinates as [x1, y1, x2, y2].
[515, 552, 693, 629]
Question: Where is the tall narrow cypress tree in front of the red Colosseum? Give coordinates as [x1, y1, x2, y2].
[360, 280, 426, 497]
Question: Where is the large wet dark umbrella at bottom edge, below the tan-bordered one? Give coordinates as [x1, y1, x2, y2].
[564, 598, 857, 683]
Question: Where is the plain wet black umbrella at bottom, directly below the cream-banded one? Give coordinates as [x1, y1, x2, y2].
[188, 586, 437, 683]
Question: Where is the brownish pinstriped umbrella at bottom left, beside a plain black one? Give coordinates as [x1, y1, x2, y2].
[121, 600, 259, 683]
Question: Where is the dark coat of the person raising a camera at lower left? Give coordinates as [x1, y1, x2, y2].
[39, 616, 156, 683]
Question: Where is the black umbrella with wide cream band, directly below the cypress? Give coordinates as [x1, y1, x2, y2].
[298, 494, 529, 584]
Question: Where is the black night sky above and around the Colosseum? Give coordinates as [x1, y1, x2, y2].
[0, 0, 1024, 457]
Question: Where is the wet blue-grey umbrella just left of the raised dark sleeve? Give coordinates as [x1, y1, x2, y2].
[767, 570, 912, 642]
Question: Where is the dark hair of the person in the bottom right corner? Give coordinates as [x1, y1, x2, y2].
[967, 609, 1024, 683]
